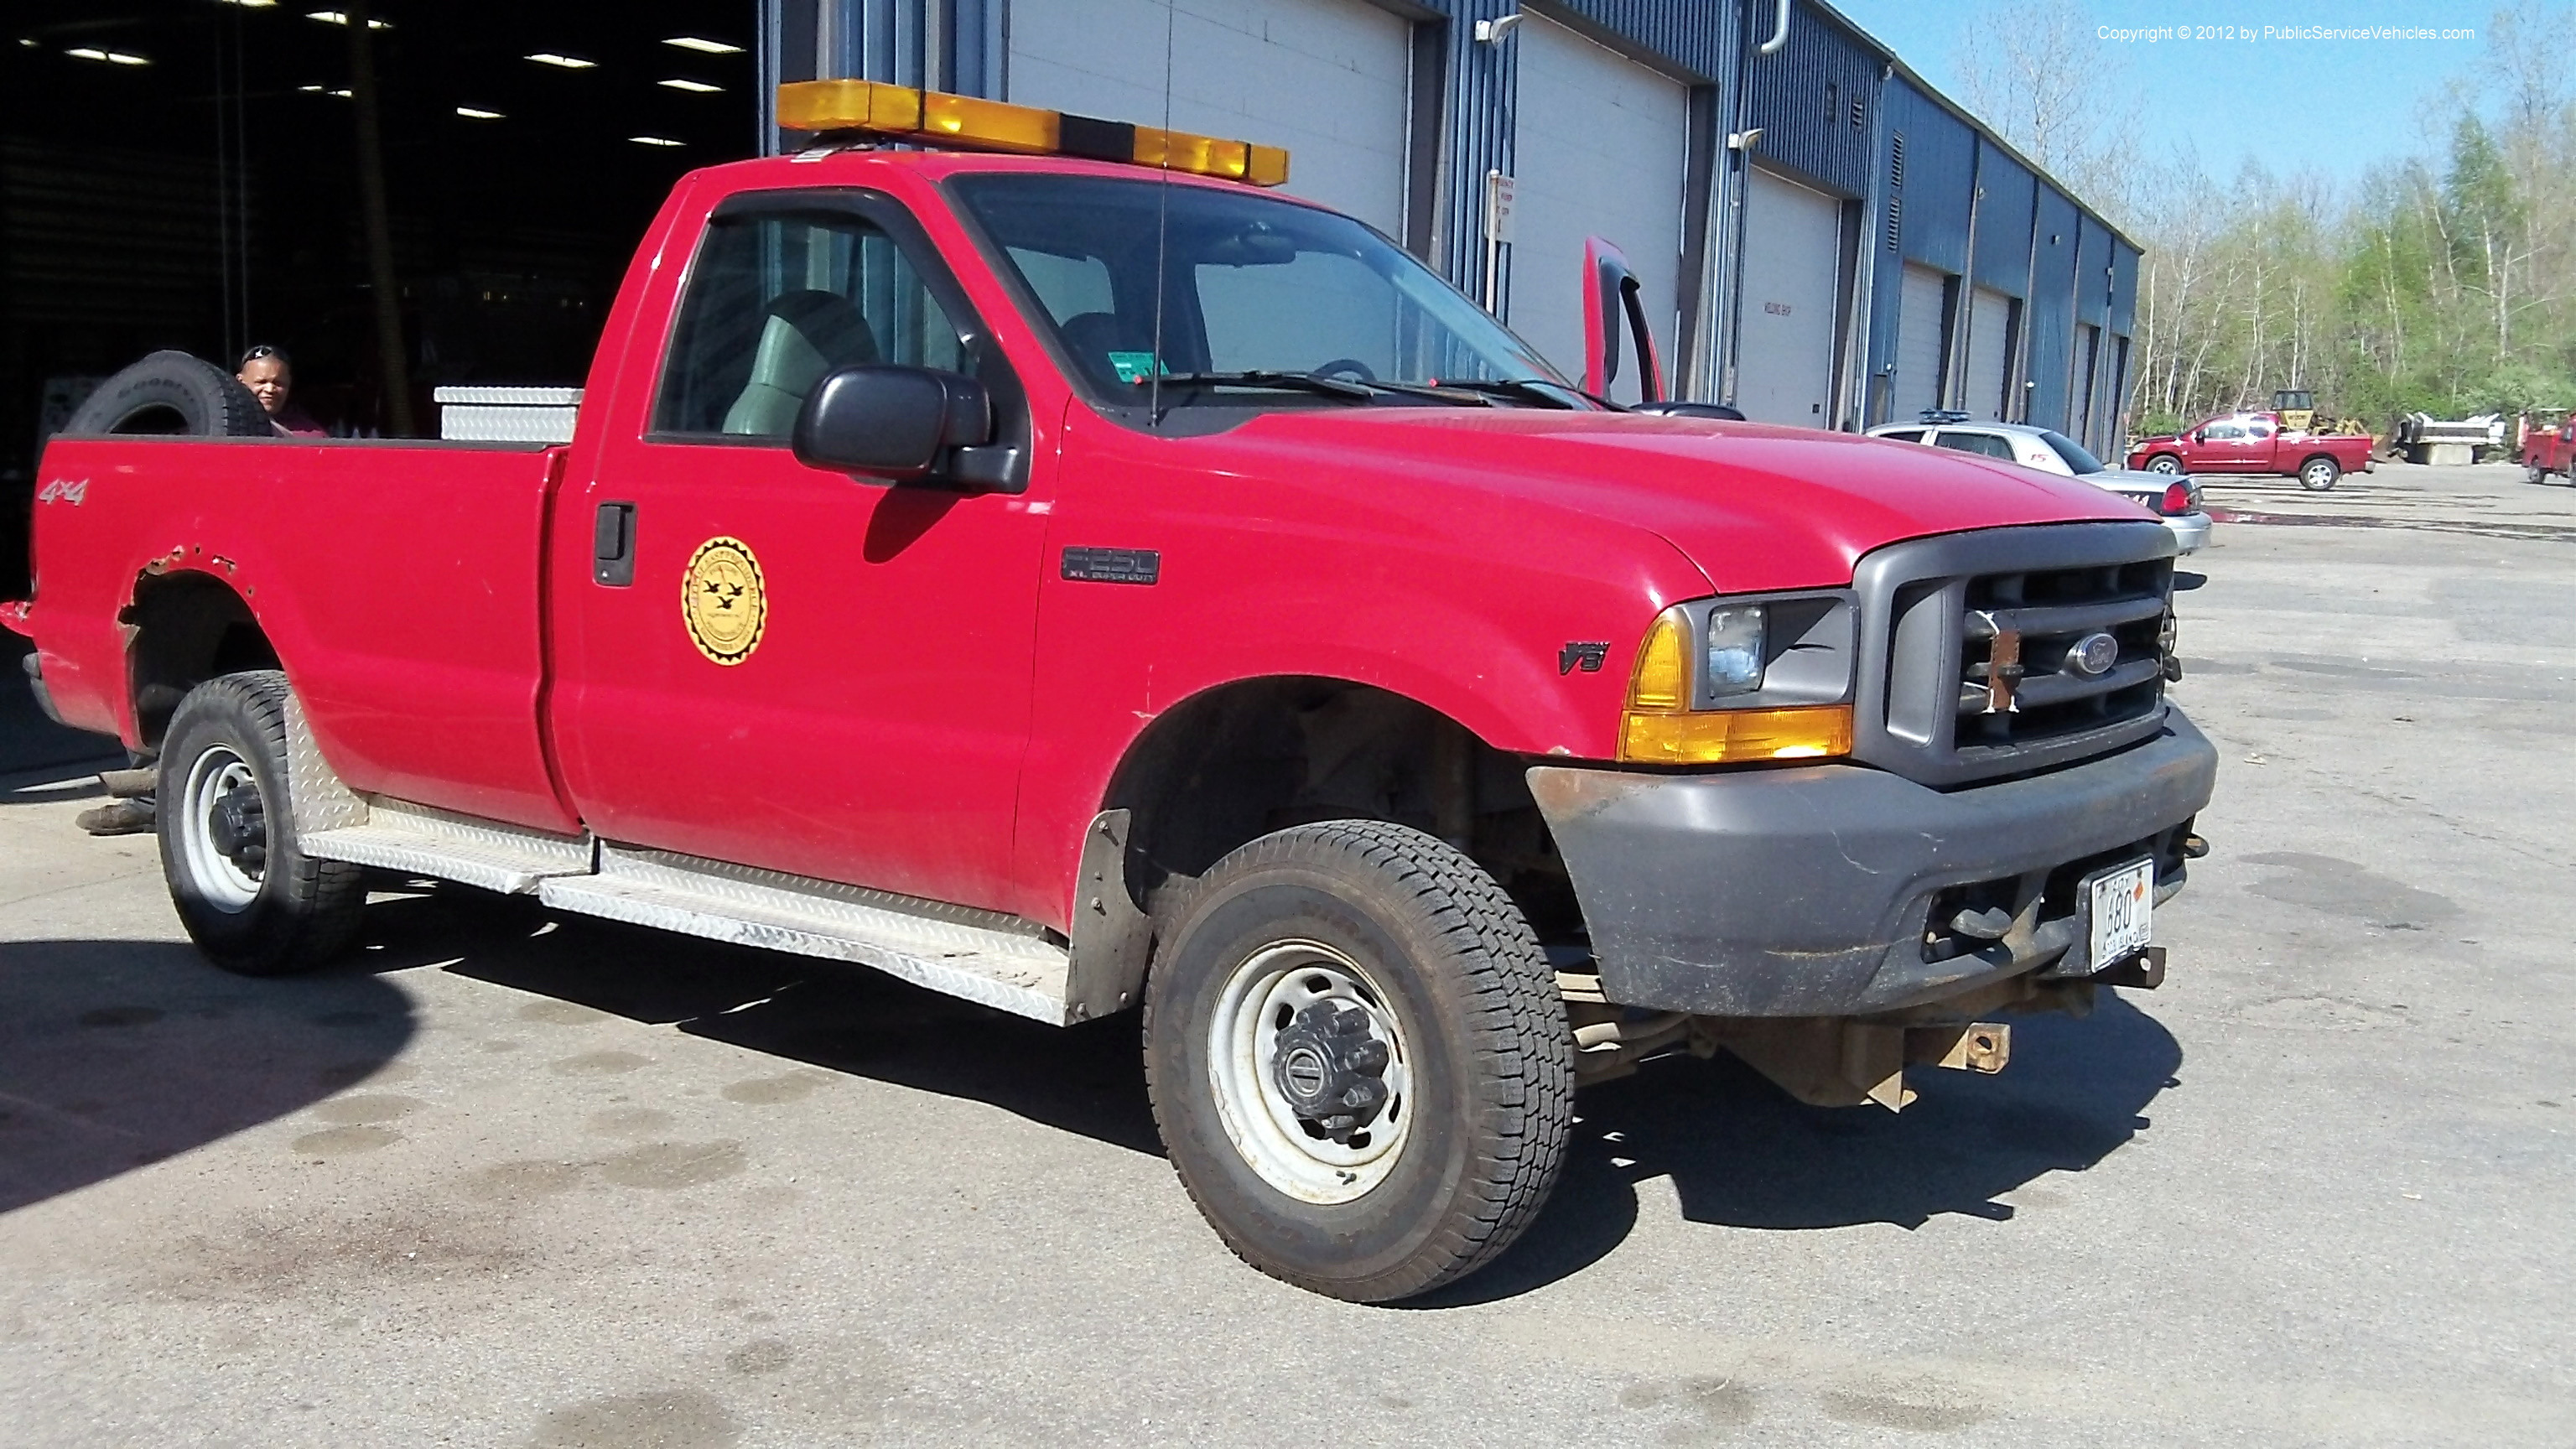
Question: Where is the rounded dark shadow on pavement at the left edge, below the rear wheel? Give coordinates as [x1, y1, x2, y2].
[0, 941, 413, 1212]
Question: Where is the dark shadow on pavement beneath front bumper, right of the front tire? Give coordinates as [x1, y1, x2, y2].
[1406, 993, 2182, 1307]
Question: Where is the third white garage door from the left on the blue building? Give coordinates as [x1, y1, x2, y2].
[1737, 168, 1841, 428]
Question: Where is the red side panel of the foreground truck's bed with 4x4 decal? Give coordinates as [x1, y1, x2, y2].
[26, 439, 574, 830]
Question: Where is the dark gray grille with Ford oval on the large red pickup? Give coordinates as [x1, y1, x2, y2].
[1852, 523, 2174, 787]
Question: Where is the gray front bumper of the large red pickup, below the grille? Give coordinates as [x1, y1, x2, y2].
[1530, 709, 2218, 1015]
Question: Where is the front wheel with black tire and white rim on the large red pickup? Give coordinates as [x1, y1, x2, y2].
[1144, 820, 1574, 1302]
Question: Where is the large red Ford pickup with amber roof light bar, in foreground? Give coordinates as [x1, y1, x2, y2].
[0, 85, 2215, 1302]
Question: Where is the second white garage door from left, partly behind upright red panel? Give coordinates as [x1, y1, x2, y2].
[1504, 15, 1690, 400]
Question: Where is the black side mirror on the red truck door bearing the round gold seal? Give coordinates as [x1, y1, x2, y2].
[788, 364, 1017, 487]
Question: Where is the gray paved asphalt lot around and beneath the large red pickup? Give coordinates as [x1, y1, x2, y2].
[0, 467, 2576, 1446]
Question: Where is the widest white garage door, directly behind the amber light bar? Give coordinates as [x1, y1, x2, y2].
[1010, 0, 1411, 240]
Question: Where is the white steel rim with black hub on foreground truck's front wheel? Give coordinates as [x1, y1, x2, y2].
[1208, 941, 1415, 1204]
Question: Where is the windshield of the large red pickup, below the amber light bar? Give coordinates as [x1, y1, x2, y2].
[951, 173, 1581, 408]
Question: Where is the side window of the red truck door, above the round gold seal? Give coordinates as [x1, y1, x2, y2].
[654, 214, 963, 433]
